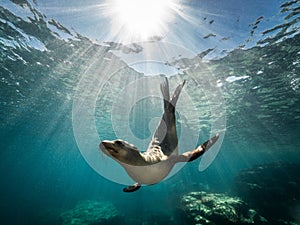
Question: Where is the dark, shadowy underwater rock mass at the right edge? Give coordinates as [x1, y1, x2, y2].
[234, 163, 300, 224]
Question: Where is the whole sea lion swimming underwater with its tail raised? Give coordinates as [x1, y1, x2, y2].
[99, 78, 219, 192]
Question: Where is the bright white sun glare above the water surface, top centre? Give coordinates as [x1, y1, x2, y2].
[106, 0, 178, 39]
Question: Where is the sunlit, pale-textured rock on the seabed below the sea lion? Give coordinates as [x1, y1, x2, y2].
[181, 191, 269, 225]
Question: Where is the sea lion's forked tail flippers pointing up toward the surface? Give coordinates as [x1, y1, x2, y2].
[160, 77, 185, 112]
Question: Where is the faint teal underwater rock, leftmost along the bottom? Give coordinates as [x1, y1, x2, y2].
[60, 201, 120, 225]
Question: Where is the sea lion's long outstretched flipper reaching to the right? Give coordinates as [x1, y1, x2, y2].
[176, 134, 219, 162]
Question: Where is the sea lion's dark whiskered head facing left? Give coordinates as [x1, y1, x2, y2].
[99, 139, 142, 165]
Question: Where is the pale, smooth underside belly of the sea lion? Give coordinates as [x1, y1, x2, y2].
[121, 160, 174, 185]
